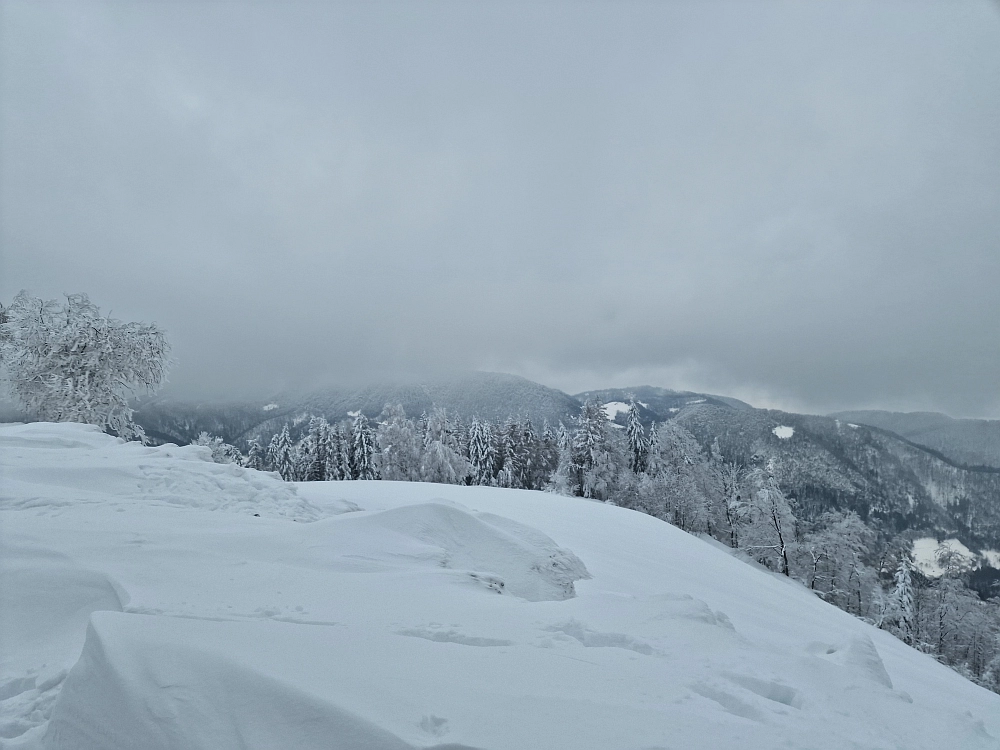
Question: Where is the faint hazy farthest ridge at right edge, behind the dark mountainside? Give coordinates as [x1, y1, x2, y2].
[831, 410, 1000, 468]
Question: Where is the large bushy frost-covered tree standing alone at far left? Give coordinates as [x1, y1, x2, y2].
[0, 291, 169, 440]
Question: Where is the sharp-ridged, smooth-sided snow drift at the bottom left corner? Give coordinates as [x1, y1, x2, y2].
[44, 613, 412, 750]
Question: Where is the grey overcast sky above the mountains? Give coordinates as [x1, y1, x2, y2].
[0, 0, 1000, 417]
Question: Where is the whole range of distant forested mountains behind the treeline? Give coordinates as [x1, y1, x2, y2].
[39, 373, 1000, 550]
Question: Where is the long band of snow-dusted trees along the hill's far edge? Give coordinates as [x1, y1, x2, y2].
[197, 401, 1000, 692]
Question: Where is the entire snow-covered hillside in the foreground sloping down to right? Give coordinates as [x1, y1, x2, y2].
[0, 424, 1000, 750]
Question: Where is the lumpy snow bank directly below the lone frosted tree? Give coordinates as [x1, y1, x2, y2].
[0, 422, 329, 521]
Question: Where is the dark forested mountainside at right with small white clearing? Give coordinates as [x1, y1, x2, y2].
[676, 404, 1000, 549]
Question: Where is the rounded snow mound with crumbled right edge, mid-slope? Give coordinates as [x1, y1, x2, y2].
[297, 503, 590, 602]
